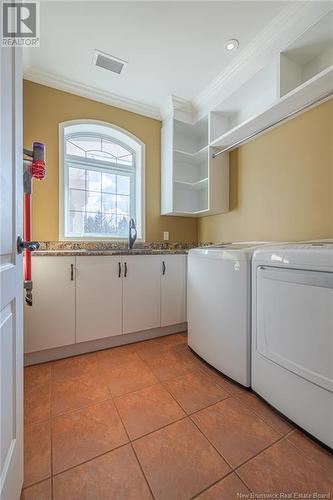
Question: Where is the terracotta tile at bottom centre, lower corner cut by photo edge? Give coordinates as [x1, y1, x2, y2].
[133, 419, 230, 500]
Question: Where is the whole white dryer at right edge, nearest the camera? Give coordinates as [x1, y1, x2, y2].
[252, 242, 333, 447]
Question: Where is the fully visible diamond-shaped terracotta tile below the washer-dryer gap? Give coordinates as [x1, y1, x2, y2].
[191, 398, 280, 467]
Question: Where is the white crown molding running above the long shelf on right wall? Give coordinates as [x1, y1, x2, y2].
[192, 1, 333, 117]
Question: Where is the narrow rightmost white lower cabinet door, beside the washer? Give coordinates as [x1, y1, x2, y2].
[161, 255, 187, 326]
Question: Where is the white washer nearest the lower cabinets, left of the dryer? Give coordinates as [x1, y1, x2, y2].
[187, 242, 267, 387]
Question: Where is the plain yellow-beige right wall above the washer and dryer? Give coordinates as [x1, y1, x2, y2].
[198, 99, 333, 242]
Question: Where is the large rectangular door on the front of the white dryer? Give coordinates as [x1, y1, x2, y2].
[254, 267, 333, 392]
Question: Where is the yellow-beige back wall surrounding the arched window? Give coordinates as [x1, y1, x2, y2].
[24, 81, 197, 241]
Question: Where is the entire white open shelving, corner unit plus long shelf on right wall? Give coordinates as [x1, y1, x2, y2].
[161, 11, 333, 217]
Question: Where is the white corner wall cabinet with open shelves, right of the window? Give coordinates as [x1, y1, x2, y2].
[161, 115, 229, 217]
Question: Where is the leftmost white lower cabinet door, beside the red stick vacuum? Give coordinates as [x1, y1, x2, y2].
[24, 256, 75, 352]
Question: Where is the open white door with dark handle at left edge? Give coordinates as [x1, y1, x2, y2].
[0, 47, 23, 500]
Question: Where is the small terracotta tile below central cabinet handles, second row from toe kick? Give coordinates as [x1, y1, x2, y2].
[103, 359, 157, 397]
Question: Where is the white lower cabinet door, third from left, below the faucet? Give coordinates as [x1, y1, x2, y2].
[123, 255, 161, 333]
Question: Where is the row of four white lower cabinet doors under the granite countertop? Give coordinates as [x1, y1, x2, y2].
[24, 254, 187, 353]
